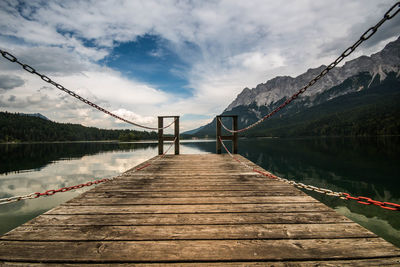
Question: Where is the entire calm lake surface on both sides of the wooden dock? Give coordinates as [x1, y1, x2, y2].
[0, 137, 400, 247]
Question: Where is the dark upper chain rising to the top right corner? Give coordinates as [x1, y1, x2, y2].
[220, 2, 400, 133]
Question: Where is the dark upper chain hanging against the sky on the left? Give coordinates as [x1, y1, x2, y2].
[0, 49, 176, 130]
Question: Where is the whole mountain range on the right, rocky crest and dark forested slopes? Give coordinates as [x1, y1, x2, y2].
[187, 38, 400, 137]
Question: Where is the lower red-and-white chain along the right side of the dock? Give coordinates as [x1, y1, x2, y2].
[219, 137, 400, 211]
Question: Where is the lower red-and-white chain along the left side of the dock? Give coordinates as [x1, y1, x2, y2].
[0, 137, 177, 205]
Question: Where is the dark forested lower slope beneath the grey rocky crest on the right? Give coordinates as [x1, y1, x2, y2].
[191, 72, 400, 137]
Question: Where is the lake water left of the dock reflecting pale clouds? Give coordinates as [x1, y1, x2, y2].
[0, 141, 211, 234]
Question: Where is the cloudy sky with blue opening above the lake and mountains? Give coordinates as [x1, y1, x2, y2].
[0, 0, 400, 131]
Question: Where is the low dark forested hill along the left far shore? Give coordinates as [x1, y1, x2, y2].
[0, 112, 158, 142]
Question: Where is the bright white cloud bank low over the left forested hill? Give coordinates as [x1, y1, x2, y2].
[0, 68, 175, 128]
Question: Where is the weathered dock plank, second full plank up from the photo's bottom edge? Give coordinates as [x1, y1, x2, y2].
[0, 223, 376, 241]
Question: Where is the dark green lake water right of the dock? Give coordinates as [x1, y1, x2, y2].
[239, 137, 400, 247]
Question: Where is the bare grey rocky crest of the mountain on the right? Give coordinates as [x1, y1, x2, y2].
[225, 37, 400, 111]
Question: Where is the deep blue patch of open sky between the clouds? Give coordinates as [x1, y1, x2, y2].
[99, 35, 192, 97]
